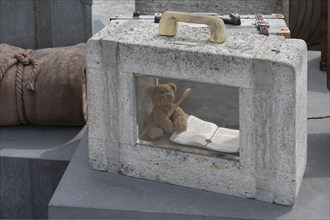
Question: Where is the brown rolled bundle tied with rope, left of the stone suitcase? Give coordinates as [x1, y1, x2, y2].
[0, 44, 87, 125]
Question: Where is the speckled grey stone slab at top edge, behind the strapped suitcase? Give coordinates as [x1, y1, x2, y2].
[135, 0, 289, 20]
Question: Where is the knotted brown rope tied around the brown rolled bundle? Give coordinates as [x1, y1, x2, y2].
[0, 50, 40, 124]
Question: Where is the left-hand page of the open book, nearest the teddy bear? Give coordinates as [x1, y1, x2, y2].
[170, 115, 218, 147]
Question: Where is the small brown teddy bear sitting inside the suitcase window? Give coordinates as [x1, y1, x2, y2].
[147, 83, 187, 141]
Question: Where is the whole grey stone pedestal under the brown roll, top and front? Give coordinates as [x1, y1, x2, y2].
[0, 126, 85, 219]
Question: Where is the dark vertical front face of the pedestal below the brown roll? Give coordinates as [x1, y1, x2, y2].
[0, 157, 69, 219]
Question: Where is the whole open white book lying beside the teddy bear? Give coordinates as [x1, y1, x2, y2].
[170, 115, 239, 153]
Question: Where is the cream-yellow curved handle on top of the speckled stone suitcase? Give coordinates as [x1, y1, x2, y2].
[159, 11, 227, 43]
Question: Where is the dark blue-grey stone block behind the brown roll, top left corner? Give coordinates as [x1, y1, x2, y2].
[0, 0, 93, 49]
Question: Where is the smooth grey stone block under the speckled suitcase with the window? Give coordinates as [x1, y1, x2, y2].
[49, 122, 329, 220]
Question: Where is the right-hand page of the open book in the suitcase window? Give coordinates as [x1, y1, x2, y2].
[206, 127, 239, 153]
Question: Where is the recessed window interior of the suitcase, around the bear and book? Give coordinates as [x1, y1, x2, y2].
[135, 74, 239, 160]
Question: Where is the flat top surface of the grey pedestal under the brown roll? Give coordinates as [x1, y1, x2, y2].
[0, 125, 86, 161]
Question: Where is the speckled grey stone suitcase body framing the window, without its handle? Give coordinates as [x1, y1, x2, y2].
[87, 20, 307, 205]
